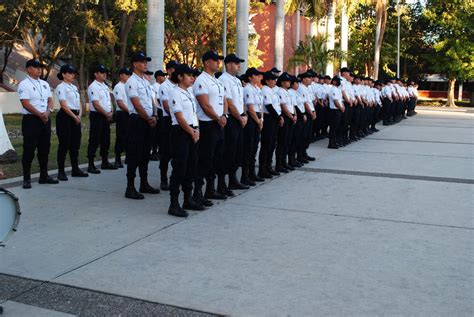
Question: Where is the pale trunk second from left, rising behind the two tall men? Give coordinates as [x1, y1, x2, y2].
[235, 0, 249, 74]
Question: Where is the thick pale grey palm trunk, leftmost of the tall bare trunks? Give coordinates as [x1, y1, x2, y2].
[146, 0, 165, 71]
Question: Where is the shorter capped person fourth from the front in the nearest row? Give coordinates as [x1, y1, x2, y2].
[240, 67, 264, 186]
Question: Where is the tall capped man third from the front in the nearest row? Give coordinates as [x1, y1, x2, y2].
[219, 54, 249, 190]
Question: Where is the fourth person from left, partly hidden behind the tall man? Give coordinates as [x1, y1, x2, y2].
[113, 68, 132, 168]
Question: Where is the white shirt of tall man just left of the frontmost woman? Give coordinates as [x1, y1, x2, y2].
[125, 73, 154, 117]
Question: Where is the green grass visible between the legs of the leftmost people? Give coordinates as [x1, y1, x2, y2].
[0, 113, 115, 178]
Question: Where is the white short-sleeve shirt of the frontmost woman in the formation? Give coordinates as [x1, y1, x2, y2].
[168, 86, 199, 127]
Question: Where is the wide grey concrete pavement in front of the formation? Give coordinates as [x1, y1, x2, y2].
[0, 109, 474, 316]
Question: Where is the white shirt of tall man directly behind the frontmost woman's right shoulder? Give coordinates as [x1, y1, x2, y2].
[193, 72, 226, 121]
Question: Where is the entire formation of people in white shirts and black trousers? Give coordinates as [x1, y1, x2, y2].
[19, 56, 416, 217]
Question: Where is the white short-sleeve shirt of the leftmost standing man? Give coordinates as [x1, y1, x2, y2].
[18, 76, 52, 114]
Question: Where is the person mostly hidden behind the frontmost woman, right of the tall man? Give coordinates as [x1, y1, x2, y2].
[158, 61, 178, 190]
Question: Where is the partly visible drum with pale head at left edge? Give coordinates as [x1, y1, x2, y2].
[0, 188, 21, 246]
